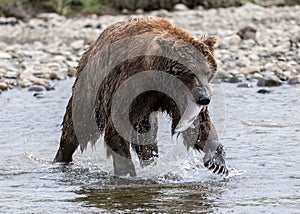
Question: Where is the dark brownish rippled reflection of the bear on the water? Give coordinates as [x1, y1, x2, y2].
[53, 166, 227, 213]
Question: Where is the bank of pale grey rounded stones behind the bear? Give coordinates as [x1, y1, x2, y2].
[0, 4, 300, 92]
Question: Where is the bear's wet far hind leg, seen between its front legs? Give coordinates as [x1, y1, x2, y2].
[131, 115, 158, 167]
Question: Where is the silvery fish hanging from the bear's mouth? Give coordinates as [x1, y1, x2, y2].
[174, 99, 203, 134]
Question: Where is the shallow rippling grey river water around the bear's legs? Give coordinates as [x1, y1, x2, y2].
[0, 79, 300, 213]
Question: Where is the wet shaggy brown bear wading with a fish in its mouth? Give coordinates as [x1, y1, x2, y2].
[54, 18, 228, 176]
